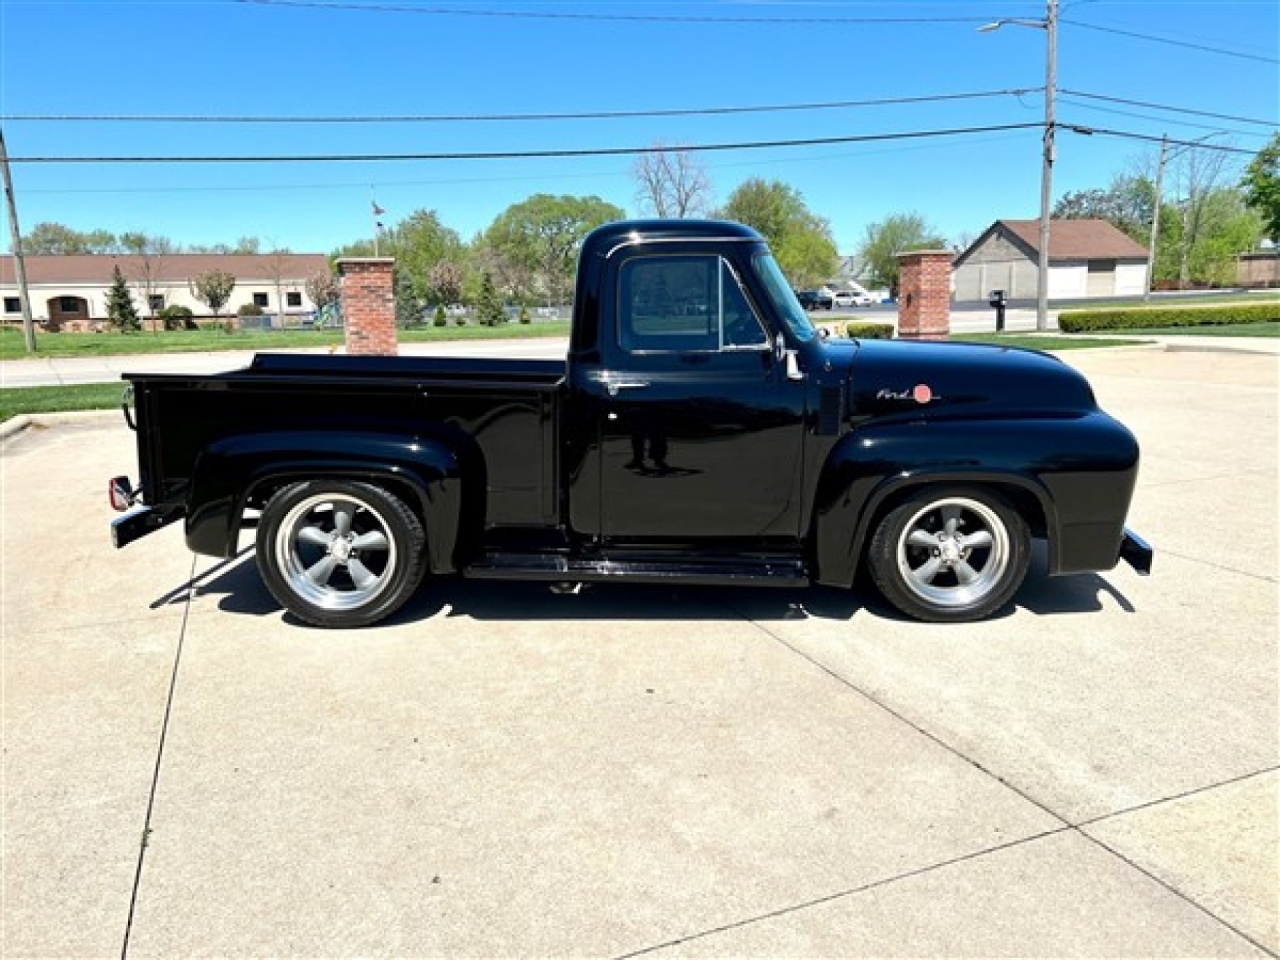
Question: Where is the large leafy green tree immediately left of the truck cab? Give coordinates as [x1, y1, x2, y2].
[483, 193, 625, 306]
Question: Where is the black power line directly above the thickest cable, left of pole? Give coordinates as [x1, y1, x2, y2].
[0, 87, 1044, 124]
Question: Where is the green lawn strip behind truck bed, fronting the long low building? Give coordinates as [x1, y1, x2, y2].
[0, 320, 568, 360]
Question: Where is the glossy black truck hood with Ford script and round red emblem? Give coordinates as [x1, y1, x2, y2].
[831, 340, 1097, 421]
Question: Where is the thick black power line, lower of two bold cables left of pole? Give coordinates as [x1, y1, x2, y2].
[9, 123, 1042, 164]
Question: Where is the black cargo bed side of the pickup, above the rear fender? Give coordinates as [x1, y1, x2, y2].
[124, 353, 564, 535]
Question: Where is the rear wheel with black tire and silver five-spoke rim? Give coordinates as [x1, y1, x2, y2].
[257, 480, 426, 627]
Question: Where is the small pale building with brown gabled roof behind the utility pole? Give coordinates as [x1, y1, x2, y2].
[951, 220, 1147, 302]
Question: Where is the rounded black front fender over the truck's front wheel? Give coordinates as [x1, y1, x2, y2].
[812, 412, 1138, 586]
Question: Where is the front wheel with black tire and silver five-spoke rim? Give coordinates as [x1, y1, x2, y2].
[867, 486, 1030, 623]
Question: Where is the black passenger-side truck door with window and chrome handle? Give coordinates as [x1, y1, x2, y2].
[591, 252, 805, 543]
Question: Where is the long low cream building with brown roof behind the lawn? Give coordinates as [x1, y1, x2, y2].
[0, 253, 329, 330]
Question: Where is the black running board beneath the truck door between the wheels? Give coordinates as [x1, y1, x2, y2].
[462, 553, 810, 586]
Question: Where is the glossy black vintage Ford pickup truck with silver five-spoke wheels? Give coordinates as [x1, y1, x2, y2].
[111, 221, 1152, 627]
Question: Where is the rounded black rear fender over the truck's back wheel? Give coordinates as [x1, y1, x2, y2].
[186, 430, 471, 573]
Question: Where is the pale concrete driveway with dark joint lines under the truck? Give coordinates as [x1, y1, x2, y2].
[0, 349, 1280, 957]
